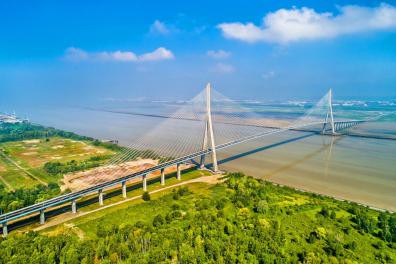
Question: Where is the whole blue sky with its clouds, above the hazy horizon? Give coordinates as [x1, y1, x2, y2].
[0, 0, 396, 105]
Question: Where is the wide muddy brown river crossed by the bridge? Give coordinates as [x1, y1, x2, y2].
[15, 100, 396, 211]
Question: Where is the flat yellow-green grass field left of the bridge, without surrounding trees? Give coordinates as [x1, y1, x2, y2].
[0, 137, 113, 190]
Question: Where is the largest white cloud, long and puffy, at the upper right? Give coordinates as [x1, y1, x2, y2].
[217, 3, 396, 43]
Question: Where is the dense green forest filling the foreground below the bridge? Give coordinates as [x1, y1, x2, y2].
[0, 173, 396, 263]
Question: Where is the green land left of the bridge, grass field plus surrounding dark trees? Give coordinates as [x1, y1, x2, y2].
[0, 123, 122, 213]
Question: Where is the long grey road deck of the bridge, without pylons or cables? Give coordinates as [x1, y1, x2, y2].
[0, 120, 362, 235]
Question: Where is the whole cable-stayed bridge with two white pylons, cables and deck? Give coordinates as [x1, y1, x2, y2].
[0, 84, 390, 235]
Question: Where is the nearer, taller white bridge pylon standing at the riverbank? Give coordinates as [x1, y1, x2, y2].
[200, 83, 219, 172]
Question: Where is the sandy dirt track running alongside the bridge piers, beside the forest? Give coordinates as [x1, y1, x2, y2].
[33, 174, 224, 233]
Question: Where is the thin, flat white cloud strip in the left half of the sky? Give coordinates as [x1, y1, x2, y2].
[64, 47, 175, 62]
